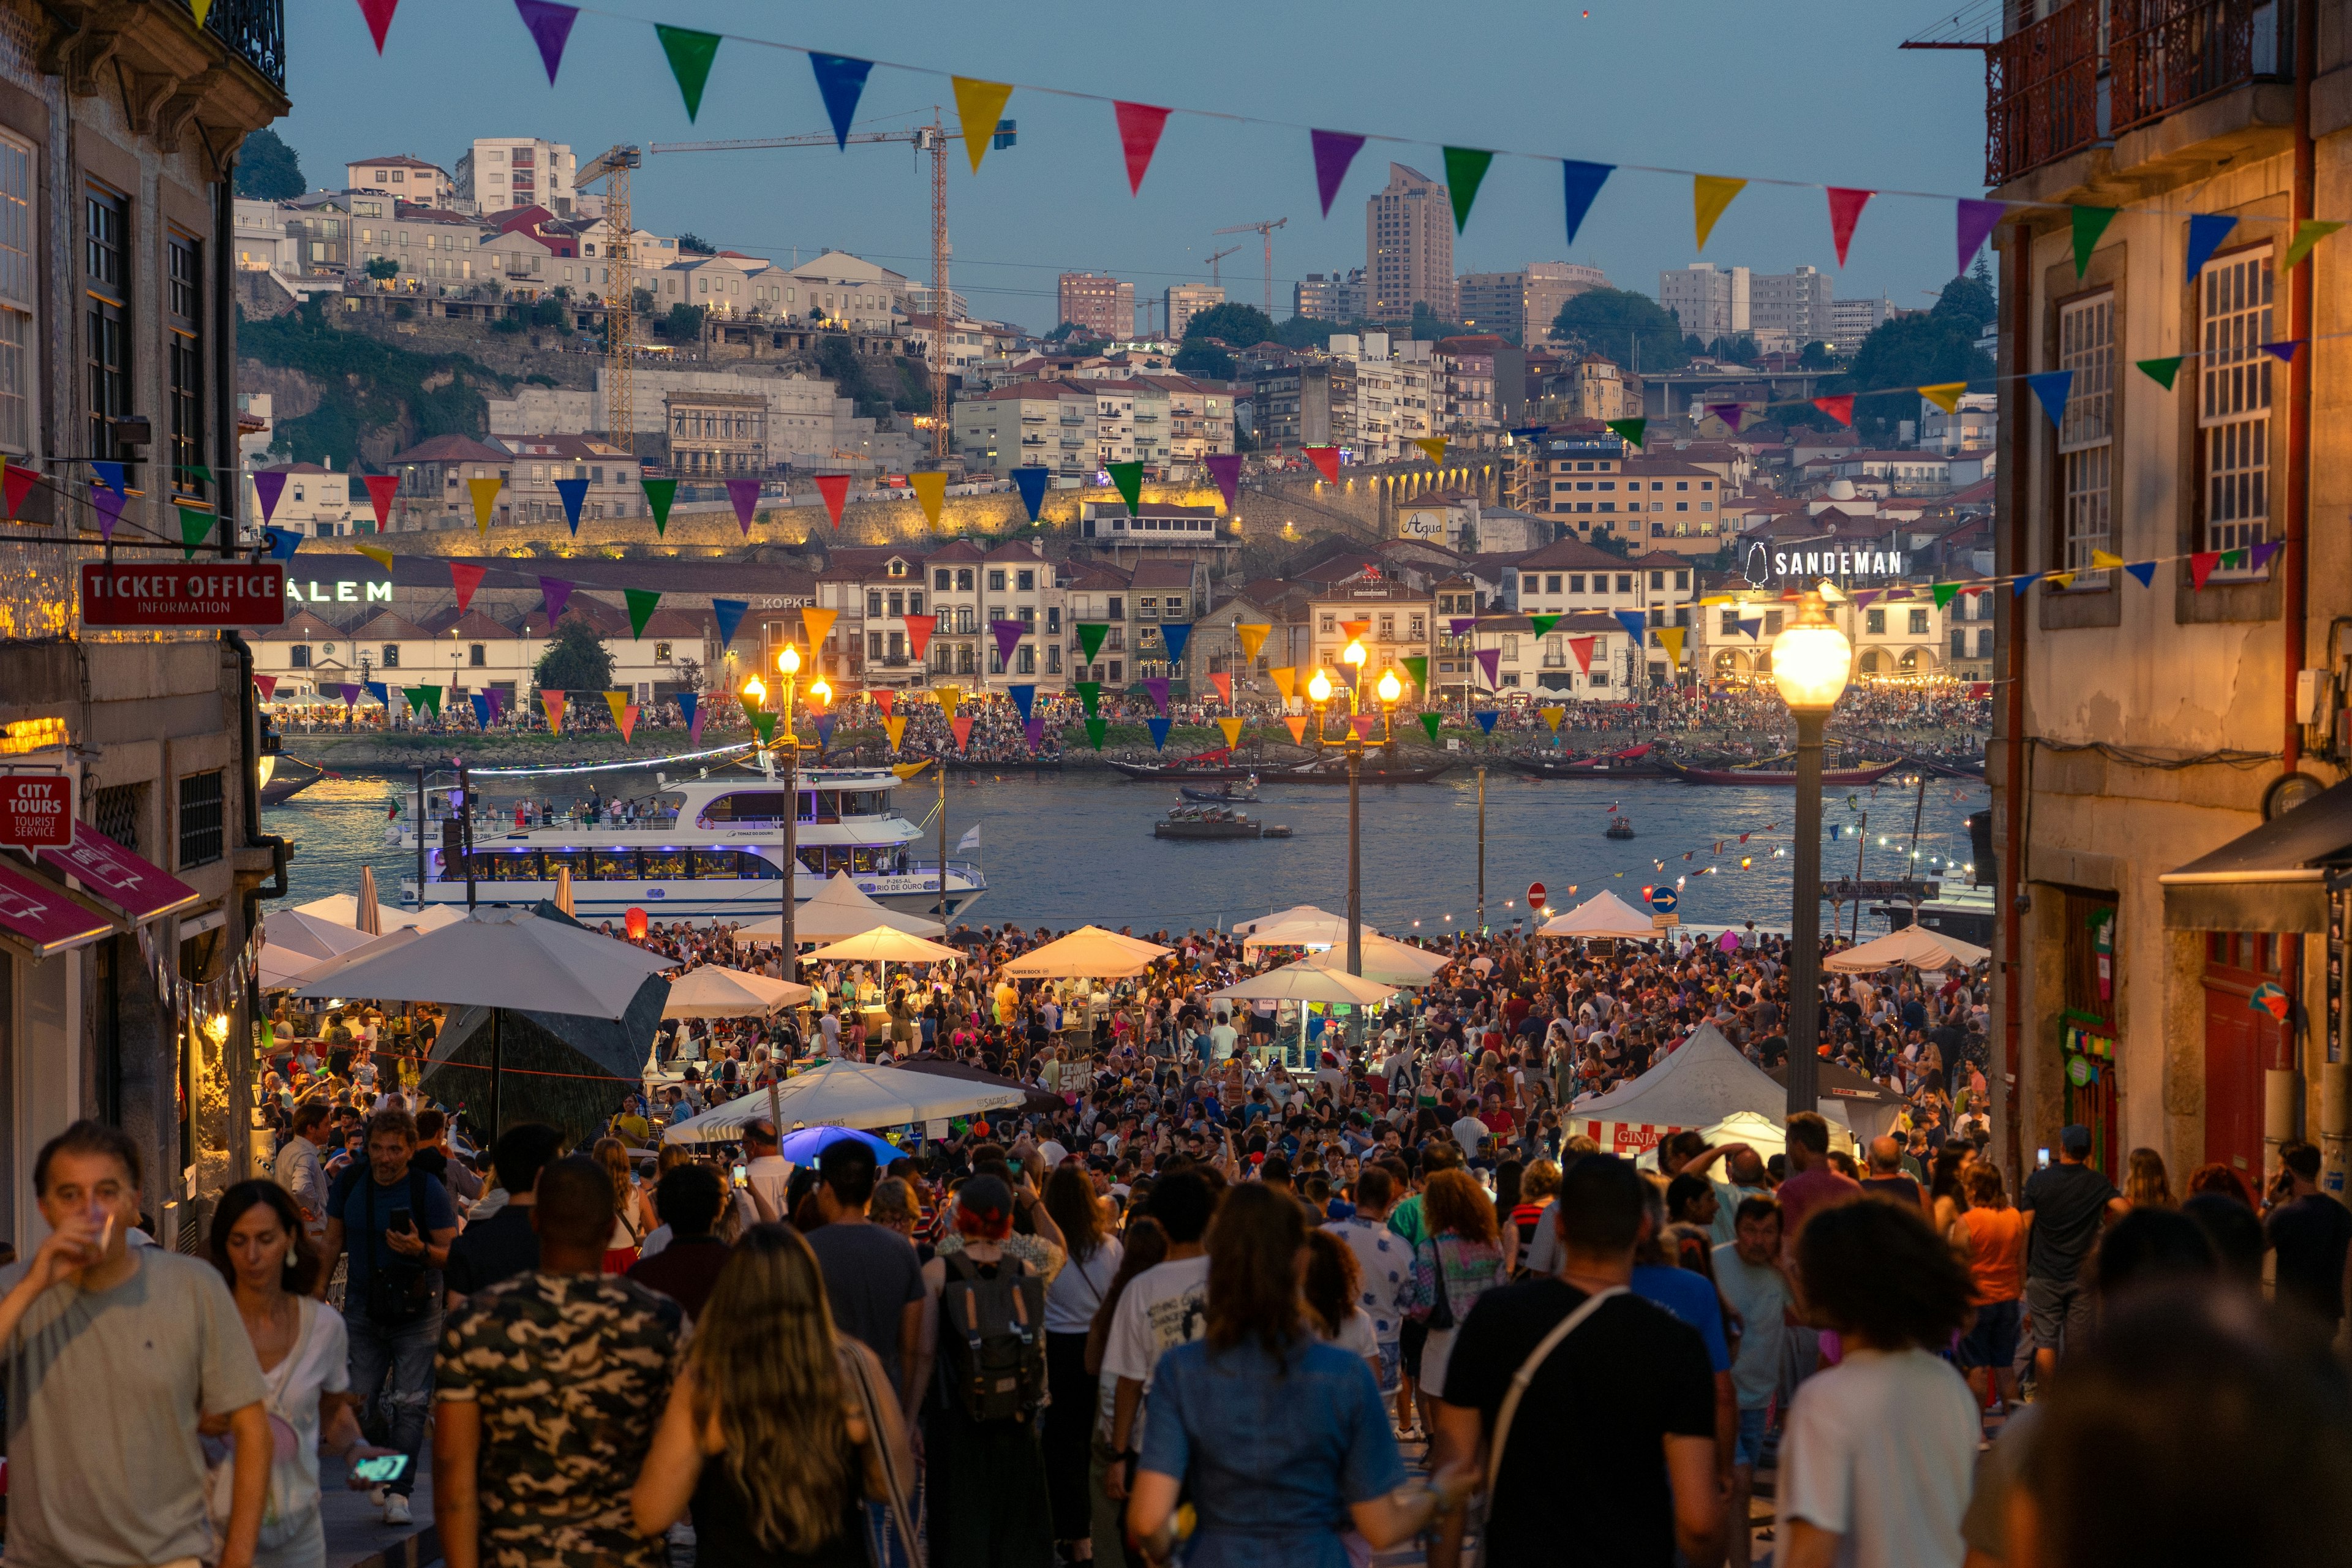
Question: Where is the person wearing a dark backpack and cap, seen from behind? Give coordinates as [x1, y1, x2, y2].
[922, 1175, 1054, 1568]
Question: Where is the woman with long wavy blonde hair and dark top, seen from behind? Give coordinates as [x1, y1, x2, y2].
[628, 1225, 915, 1568]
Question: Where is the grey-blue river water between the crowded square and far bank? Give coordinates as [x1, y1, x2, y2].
[263, 769, 1988, 936]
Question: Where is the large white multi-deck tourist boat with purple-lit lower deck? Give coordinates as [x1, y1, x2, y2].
[386, 766, 988, 926]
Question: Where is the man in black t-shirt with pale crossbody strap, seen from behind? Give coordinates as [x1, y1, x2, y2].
[1428, 1154, 1724, 1568]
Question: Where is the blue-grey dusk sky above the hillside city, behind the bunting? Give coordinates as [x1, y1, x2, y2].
[277, 0, 1985, 331]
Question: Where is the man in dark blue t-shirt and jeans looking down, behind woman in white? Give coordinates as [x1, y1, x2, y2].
[320, 1110, 456, 1526]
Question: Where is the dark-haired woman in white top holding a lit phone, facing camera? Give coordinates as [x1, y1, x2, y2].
[202, 1183, 395, 1568]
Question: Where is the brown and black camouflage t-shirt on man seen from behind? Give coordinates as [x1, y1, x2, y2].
[433, 1272, 682, 1568]
